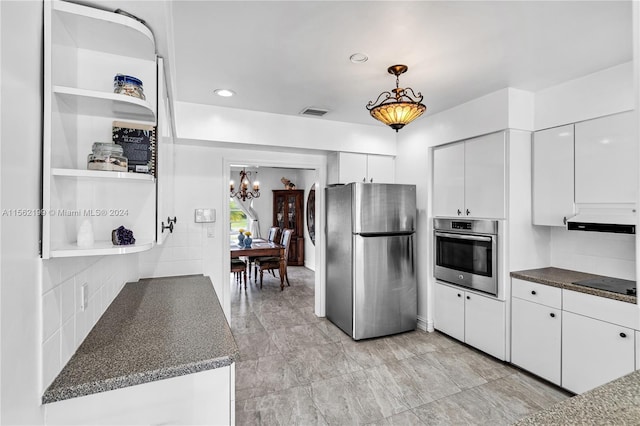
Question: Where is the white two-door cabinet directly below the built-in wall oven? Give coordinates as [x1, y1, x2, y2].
[434, 283, 506, 360]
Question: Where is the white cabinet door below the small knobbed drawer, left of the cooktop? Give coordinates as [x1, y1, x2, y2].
[511, 297, 562, 385]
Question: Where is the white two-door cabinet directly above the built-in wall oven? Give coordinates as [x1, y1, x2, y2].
[433, 132, 506, 219]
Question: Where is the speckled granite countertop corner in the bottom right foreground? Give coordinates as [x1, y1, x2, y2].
[516, 370, 640, 426]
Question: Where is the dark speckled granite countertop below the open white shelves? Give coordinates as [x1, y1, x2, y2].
[42, 275, 239, 404]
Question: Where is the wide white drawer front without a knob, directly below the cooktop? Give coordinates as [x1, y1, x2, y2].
[562, 289, 640, 330]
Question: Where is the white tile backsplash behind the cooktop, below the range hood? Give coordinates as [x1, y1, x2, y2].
[551, 228, 636, 281]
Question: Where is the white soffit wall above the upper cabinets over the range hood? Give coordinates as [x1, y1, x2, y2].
[535, 62, 634, 130]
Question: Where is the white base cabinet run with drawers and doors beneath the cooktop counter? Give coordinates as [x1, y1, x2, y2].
[511, 278, 640, 393]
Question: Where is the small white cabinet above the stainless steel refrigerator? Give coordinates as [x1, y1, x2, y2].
[327, 152, 395, 185]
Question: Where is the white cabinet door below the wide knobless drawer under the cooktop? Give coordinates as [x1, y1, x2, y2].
[562, 312, 635, 393]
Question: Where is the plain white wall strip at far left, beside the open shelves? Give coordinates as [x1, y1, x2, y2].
[0, 1, 43, 424]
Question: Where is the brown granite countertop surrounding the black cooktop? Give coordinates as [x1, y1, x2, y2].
[511, 268, 637, 303]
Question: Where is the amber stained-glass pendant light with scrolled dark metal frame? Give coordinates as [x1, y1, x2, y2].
[367, 65, 427, 132]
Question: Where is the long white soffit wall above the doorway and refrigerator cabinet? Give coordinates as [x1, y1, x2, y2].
[174, 102, 396, 155]
